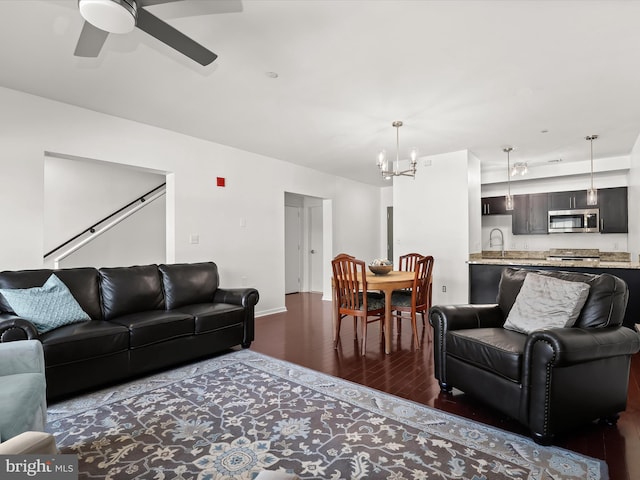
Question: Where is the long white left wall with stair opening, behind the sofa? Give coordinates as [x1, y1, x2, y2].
[0, 88, 380, 314]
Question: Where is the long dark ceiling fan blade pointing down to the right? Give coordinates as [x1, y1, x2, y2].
[136, 8, 218, 65]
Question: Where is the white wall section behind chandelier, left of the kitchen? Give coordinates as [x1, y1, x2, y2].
[393, 151, 480, 304]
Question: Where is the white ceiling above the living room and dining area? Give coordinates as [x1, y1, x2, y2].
[0, 0, 640, 185]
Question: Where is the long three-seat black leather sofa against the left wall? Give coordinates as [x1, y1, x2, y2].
[0, 262, 259, 401]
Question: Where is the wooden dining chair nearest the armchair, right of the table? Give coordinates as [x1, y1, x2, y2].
[391, 255, 433, 349]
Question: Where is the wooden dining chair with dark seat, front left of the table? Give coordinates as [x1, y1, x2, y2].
[331, 254, 384, 355]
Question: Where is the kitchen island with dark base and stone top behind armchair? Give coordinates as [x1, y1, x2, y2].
[469, 255, 640, 331]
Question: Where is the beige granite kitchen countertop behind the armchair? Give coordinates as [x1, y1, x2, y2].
[468, 250, 640, 270]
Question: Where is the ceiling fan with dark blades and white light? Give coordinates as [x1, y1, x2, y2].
[74, 0, 218, 65]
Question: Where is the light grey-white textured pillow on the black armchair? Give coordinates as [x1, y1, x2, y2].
[504, 273, 589, 334]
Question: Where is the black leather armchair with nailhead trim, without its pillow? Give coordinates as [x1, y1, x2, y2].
[429, 268, 640, 444]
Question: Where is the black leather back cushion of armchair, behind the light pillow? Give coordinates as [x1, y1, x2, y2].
[497, 268, 629, 328]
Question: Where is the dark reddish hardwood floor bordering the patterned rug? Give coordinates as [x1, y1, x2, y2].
[251, 293, 640, 480]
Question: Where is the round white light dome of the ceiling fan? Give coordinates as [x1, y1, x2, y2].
[78, 0, 138, 33]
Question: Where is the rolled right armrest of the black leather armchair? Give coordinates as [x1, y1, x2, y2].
[525, 326, 640, 367]
